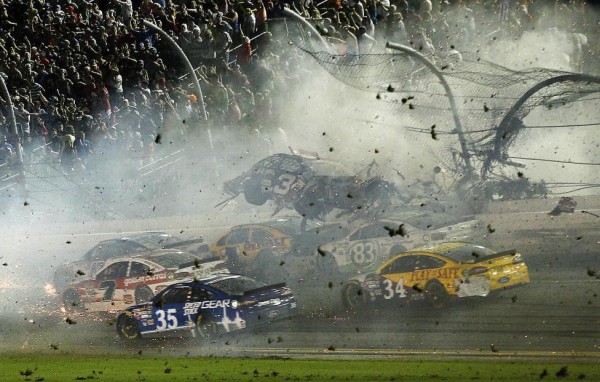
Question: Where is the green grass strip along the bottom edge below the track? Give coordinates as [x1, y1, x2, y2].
[0, 355, 600, 382]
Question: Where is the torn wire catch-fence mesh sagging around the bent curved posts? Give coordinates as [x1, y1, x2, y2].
[287, 21, 600, 185]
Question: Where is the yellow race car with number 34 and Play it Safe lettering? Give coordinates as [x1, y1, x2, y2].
[342, 242, 529, 308]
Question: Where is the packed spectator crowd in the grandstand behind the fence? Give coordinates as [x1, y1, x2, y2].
[0, 0, 597, 173]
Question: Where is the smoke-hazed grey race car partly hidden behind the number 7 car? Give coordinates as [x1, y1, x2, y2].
[53, 232, 210, 292]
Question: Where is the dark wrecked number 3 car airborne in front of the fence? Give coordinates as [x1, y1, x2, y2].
[221, 153, 398, 220]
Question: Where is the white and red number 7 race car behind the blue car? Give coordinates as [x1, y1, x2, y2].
[62, 250, 228, 312]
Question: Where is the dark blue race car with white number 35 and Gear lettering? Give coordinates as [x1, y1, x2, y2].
[116, 274, 296, 340]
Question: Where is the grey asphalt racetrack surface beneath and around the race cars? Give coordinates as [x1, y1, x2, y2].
[0, 200, 600, 359]
